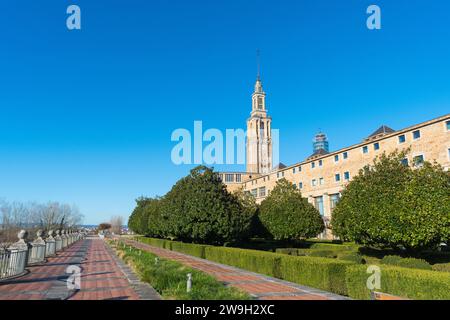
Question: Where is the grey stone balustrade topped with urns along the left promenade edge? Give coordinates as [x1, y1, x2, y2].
[0, 229, 85, 281]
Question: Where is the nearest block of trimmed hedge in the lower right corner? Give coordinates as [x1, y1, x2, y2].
[345, 265, 450, 300]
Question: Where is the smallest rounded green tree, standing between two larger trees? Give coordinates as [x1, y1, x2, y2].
[259, 179, 325, 240]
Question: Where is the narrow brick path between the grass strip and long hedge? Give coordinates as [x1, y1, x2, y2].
[125, 240, 348, 300]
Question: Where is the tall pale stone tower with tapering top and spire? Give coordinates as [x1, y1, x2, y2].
[247, 76, 272, 174]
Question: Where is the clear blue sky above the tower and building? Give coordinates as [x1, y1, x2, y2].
[0, 0, 450, 223]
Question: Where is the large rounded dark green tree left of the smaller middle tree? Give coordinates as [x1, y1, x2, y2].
[162, 166, 252, 244]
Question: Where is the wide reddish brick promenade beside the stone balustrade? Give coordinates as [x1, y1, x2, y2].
[0, 238, 160, 300]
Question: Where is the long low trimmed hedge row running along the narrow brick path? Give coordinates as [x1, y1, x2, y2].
[137, 237, 450, 299]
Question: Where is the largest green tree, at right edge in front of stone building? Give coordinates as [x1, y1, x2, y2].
[331, 151, 450, 252]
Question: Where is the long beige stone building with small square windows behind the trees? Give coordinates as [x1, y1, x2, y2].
[220, 79, 450, 238]
